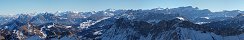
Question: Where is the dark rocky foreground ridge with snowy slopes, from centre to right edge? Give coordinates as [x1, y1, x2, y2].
[101, 19, 244, 40]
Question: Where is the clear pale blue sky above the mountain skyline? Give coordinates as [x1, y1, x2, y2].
[0, 0, 244, 15]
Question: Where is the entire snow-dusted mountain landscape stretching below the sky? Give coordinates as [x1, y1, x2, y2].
[0, 6, 244, 40]
